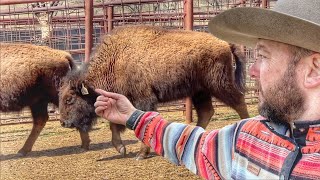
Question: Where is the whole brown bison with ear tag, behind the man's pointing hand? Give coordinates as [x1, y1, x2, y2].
[59, 26, 249, 159]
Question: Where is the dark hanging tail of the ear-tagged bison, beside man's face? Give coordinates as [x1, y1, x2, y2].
[230, 44, 246, 93]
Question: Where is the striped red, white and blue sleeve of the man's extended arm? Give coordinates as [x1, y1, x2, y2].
[134, 112, 237, 179]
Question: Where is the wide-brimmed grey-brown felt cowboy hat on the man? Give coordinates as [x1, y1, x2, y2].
[209, 0, 320, 52]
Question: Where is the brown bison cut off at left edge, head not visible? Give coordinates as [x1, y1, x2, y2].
[0, 43, 89, 155]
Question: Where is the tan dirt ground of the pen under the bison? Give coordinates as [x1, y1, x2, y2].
[0, 105, 257, 180]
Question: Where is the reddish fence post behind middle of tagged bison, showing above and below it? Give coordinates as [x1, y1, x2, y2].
[183, 0, 193, 124]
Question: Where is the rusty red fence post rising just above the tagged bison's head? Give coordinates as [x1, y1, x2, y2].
[84, 0, 93, 62]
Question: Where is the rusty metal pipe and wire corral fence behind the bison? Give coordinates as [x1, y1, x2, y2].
[0, 0, 275, 125]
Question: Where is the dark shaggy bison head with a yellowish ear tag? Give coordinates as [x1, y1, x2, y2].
[59, 70, 98, 132]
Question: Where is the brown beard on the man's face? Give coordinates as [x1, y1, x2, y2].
[259, 64, 304, 124]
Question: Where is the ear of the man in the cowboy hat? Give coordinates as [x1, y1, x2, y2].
[304, 53, 320, 88]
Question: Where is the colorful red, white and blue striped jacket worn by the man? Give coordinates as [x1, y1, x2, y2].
[134, 112, 320, 179]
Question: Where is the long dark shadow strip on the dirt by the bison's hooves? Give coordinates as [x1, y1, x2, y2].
[0, 140, 138, 162]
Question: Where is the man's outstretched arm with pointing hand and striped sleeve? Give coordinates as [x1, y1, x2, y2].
[95, 90, 236, 179]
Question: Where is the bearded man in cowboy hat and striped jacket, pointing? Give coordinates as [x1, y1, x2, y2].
[95, 0, 320, 179]
